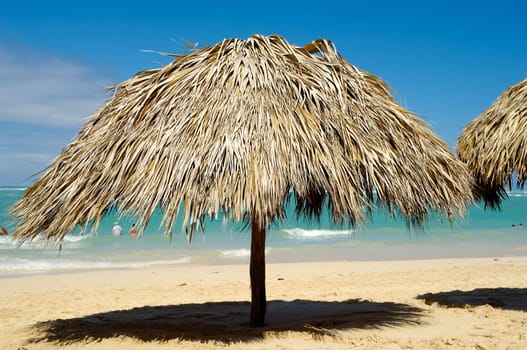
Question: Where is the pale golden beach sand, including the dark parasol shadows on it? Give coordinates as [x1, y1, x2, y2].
[0, 257, 527, 350]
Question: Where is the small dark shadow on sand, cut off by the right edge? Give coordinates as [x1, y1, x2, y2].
[417, 288, 527, 311]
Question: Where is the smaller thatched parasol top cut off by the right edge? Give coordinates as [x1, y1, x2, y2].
[457, 79, 527, 208]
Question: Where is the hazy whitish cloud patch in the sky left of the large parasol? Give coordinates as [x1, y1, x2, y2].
[0, 45, 111, 128]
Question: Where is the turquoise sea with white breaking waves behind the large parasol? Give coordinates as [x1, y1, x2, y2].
[0, 187, 527, 277]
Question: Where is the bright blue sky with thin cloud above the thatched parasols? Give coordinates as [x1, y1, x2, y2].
[0, 0, 527, 186]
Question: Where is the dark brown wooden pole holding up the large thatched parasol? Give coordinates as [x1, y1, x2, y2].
[249, 218, 267, 327]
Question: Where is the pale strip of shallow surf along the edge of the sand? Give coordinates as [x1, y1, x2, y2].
[0, 244, 527, 281]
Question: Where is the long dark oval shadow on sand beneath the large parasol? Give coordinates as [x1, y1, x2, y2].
[29, 300, 424, 344]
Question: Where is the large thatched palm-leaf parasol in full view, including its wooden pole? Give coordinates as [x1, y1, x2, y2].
[14, 35, 471, 325]
